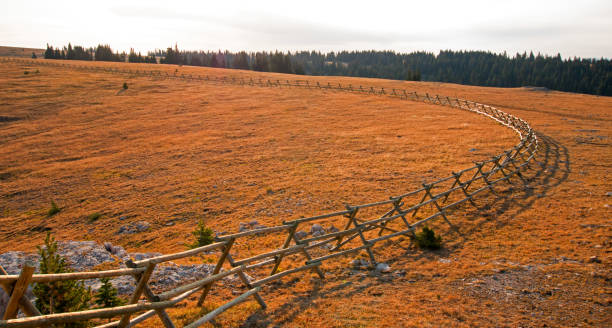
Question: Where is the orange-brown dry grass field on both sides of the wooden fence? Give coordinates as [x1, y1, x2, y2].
[0, 60, 612, 327]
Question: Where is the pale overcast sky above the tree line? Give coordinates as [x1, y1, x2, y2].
[0, 0, 612, 58]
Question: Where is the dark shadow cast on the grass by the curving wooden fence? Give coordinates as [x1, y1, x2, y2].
[240, 133, 571, 328]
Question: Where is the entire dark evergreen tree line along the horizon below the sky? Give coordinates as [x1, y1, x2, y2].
[45, 44, 612, 96]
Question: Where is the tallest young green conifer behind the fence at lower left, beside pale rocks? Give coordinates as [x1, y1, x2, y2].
[33, 233, 91, 328]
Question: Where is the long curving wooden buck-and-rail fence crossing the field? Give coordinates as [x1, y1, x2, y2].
[0, 58, 538, 327]
